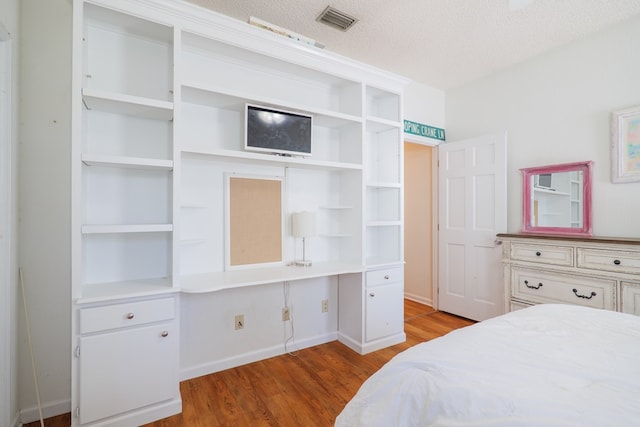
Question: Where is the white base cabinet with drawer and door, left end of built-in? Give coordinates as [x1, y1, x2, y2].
[76, 297, 181, 425]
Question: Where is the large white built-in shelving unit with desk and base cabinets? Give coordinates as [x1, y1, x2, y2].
[72, 0, 407, 425]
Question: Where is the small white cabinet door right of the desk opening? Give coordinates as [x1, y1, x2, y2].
[365, 282, 404, 341]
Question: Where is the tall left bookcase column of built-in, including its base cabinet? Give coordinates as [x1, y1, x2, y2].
[72, 0, 181, 425]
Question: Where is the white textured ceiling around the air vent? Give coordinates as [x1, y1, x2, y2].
[182, 0, 640, 89]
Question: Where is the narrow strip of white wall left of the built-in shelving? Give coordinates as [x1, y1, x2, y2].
[19, 0, 71, 421]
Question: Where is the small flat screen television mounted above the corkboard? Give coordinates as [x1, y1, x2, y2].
[245, 104, 313, 156]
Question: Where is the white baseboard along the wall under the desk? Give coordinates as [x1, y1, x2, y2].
[180, 332, 338, 381]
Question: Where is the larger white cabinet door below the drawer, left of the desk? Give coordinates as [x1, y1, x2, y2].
[79, 323, 178, 424]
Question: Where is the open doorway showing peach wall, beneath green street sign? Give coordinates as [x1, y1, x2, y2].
[404, 142, 435, 306]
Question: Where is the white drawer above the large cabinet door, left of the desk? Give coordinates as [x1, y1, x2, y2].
[80, 298, 175, 334]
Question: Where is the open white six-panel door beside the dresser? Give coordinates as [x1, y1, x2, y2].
[437, 134, 507, 320]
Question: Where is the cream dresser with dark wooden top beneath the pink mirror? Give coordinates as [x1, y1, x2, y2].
[498, 234, 640, 315]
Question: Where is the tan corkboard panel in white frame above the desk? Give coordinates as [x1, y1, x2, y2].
[229, 177, 282, 266]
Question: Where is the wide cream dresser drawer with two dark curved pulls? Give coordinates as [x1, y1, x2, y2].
[511, 268, 616, 310]
